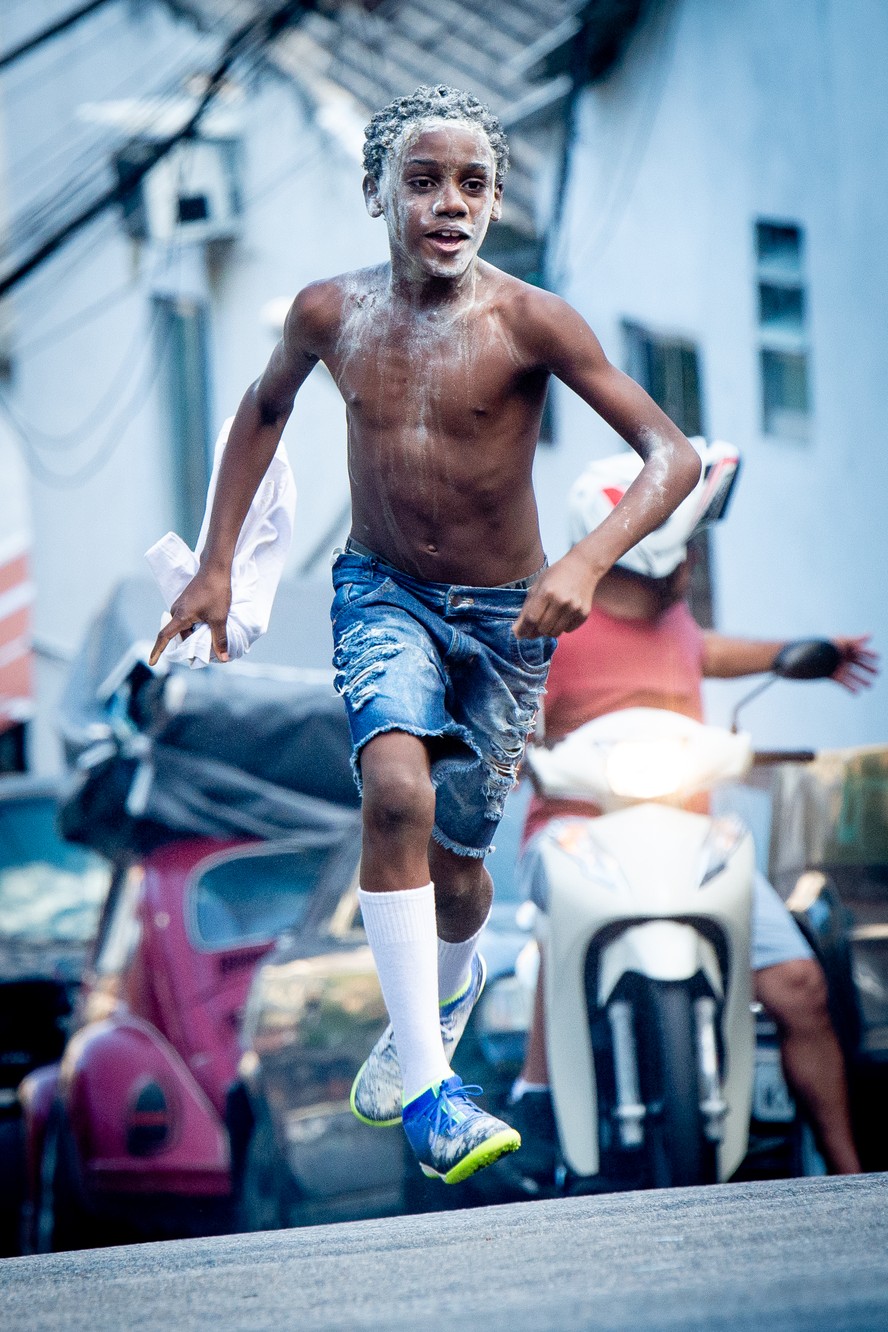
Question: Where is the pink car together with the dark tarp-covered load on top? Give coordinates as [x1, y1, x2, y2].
[20, 581, 359, 1249]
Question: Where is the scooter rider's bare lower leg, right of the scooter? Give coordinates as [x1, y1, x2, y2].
[754, 958, 860, 1175]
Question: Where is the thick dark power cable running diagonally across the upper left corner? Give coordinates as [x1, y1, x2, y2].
[0, 0, 305, 300]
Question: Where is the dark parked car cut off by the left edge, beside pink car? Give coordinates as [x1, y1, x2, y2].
[0, 775, 111, 1255]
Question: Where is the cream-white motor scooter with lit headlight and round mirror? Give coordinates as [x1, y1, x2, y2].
[516, 641, 839, 1187]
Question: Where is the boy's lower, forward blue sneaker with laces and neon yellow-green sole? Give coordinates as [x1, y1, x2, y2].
[403, 1074, 521, 1184]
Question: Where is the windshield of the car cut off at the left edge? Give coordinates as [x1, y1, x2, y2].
[0, 797, 111, 943]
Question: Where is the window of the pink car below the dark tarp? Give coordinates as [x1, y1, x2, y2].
[189, 847, 332, 950]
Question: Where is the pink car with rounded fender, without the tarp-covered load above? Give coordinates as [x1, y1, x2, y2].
[20, 839, 346, 1252]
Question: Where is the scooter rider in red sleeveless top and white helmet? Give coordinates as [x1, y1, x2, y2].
[511, 441, 879, 1176]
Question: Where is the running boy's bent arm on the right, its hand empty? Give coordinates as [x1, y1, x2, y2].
[515, 292, 700, 638]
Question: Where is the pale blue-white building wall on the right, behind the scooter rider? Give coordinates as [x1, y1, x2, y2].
[538, 0, 888, 746]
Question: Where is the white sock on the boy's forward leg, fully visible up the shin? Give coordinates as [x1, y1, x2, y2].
[358, 883, 453, 1106]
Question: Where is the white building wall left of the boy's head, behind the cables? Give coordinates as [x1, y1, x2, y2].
[0, 0, 386, 771]
